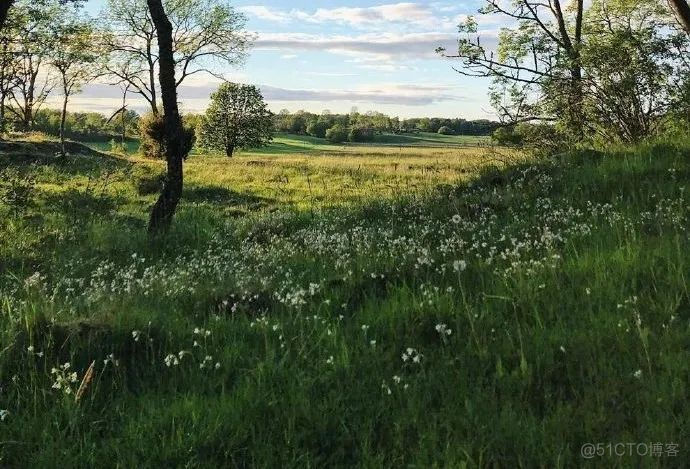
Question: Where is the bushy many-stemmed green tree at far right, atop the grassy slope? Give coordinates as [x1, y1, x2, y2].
[581, 0, 676, 142]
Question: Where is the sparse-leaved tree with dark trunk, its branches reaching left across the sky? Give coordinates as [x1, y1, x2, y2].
[437, 0, 584, 135]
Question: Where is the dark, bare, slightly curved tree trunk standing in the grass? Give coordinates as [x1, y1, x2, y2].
[146, 0, 187, 235]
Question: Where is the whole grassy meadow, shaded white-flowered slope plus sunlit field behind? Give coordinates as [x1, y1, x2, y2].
[0, 136, 690, 468]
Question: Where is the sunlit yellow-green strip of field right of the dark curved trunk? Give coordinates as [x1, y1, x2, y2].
[173, 146, 517, 207]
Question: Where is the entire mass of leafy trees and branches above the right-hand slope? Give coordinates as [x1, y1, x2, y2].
[439, 0, 690, 145]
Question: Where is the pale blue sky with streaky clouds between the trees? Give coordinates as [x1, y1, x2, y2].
[66, 0, 500, 119]
